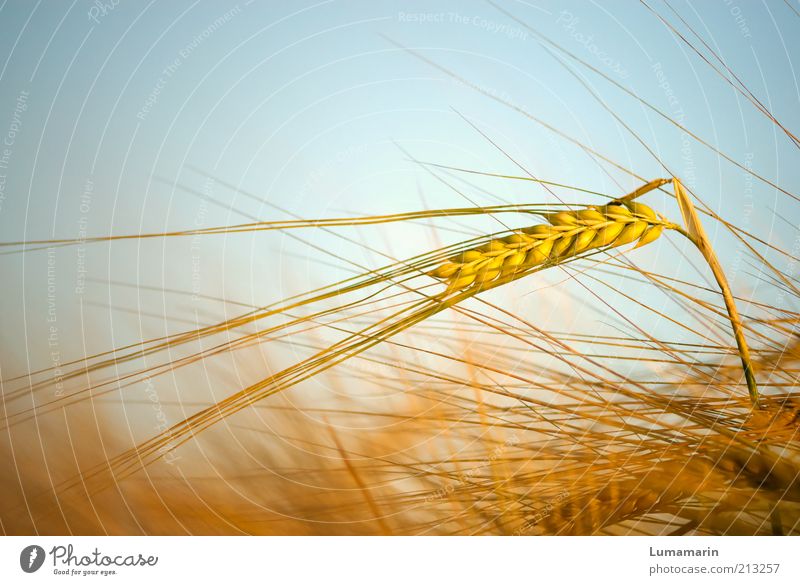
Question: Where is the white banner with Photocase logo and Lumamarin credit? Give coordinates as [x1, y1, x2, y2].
[0, 536, 800, 585]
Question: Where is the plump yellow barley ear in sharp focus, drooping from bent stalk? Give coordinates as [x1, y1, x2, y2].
[431, 201, 671, 292]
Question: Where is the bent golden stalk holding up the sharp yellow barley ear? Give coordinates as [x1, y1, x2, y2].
[672, 178, 759, 408]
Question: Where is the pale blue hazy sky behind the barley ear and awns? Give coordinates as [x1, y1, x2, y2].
[0, 0, 800, 386]
